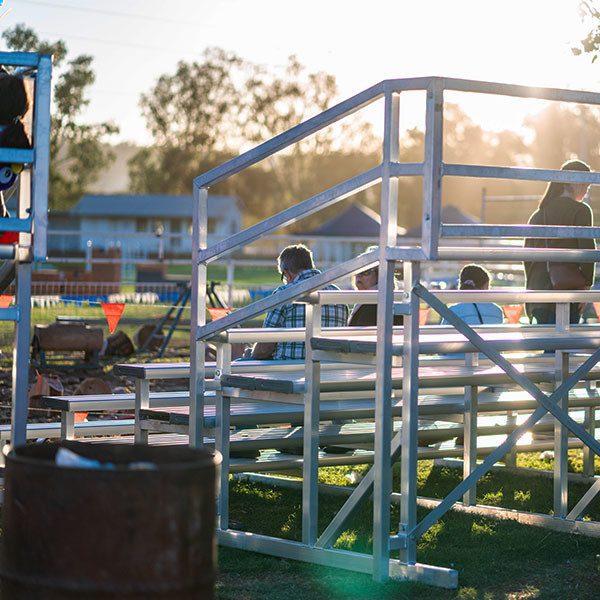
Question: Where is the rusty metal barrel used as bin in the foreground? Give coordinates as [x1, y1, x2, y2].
[0, 441, 220, 600]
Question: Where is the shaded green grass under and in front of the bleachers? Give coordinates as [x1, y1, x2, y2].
[217, 458, 600, 600]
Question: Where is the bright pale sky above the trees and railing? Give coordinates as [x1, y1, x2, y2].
[0, 0, 600, 144]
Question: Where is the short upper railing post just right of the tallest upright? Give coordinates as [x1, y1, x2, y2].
[422, 79, 444, 260]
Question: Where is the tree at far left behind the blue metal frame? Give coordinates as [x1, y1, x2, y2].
[2, 24, 118, 210]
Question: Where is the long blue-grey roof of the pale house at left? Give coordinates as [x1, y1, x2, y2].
[71, 194, 239, 218]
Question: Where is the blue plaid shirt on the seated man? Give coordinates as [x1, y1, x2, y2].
[263, 269, 348, 360]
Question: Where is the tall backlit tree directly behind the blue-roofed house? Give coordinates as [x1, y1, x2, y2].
[129, 48, 245, 194]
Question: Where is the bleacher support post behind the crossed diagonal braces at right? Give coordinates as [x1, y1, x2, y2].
[554, 302, 570, 517]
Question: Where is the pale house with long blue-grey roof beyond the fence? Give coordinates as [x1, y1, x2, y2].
[69, 194, 242, 257]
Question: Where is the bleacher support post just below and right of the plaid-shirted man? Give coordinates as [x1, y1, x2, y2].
[302, 303, 321, 546]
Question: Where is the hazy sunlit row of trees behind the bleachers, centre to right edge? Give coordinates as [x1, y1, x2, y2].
[136, 48, 580, 233]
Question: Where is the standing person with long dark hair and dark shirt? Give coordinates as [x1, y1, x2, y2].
[524, 160, 596, 324]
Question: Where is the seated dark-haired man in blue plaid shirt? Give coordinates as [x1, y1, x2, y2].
[252, 244, 348, 360]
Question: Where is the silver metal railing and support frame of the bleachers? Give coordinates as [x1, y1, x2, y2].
[190, 77, 600, 586]
